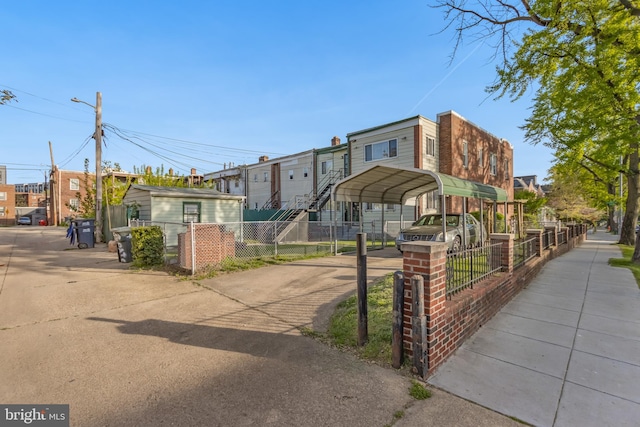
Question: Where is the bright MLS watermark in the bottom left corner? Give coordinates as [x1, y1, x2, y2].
[0, 404, 69, 427]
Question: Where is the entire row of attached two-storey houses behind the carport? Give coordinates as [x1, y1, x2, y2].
[205, 111, 513, 229]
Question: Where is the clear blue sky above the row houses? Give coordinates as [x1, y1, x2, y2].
[0, 0, 552, 184]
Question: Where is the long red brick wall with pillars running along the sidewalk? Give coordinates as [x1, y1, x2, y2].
[402, 225, 587, 376]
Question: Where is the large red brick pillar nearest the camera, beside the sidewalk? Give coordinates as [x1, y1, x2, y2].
[402, 242, 447, 372]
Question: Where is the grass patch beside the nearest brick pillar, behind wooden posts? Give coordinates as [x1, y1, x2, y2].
[327, 273, 393, 365]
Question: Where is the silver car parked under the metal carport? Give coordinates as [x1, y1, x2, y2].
[396, 214, 487, 251]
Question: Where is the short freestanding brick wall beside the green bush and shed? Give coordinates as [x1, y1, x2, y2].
[178, 224, 235, 271]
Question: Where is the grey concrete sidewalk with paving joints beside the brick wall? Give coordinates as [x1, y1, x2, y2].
[424, 232, 640, 426]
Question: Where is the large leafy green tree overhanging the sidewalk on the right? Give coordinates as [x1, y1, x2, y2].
[438, 0, 640, 254]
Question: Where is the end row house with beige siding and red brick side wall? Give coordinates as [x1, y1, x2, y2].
[347, 111, 513, 227]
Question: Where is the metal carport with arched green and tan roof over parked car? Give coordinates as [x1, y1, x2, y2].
[332, 166, 507, 247]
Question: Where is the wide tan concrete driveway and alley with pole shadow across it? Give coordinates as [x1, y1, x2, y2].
[0, 227, 515, 426]
